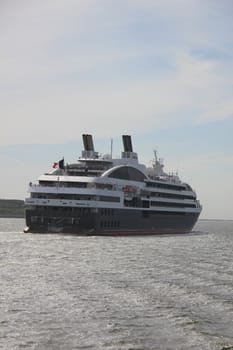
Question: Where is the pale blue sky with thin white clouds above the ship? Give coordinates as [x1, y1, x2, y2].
[0, 0, 233, 219]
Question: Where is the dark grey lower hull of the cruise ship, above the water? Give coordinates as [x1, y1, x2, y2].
[26, 206, 199, 236]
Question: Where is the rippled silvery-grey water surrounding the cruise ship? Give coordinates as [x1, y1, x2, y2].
[0, 219, 233, 350]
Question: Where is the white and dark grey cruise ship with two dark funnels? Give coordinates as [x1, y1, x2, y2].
[24, 134, 202, 236]
